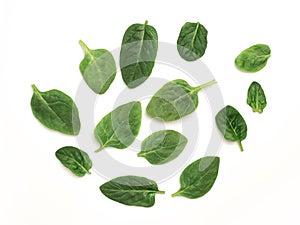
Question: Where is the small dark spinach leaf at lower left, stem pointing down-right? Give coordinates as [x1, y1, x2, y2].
[55, 146, 92, 177]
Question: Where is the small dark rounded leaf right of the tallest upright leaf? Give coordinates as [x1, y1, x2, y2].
[177, 22, 207, 61]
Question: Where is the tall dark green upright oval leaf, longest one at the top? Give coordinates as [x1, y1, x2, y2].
[120, 21, 158, 88]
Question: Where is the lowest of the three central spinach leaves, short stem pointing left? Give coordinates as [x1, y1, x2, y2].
[138, 130, 188, 165]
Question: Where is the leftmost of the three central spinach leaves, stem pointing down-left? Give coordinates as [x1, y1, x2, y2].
[94, 102, 142, 152]
